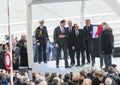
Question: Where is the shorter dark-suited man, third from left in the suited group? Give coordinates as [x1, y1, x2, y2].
[73, 24, 85, 66]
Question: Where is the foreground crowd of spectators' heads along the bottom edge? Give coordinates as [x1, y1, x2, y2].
[0, 64, 120, 85]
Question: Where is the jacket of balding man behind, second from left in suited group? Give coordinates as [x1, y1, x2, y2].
[67, 27, 74, 47]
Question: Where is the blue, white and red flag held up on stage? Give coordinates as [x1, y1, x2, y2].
[92, 25, 102, 38]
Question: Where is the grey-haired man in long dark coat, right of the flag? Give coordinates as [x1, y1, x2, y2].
[100, 22, 114, 71]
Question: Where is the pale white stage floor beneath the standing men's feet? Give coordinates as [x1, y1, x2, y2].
[33, 58, 120, 74]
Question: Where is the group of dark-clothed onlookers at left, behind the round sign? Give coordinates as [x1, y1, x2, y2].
[0, 34, 28, 70]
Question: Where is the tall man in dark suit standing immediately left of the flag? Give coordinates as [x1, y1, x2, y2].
[83, 19, 95, 66]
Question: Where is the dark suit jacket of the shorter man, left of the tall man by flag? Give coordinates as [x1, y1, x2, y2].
[73, 29, 85, 51]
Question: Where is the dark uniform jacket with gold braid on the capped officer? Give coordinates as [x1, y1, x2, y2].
[35, 26, 48, 44]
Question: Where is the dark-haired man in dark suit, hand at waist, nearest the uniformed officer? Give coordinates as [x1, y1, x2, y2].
[53, 20, 69, 68]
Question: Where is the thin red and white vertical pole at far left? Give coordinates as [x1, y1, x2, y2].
[7, 0, 13, 85]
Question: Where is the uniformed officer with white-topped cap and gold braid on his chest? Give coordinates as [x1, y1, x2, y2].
[36, 20, 48, 63]
